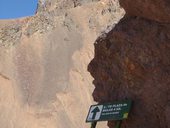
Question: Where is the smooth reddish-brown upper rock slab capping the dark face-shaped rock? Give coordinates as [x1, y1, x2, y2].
[119, 0, 170, 23]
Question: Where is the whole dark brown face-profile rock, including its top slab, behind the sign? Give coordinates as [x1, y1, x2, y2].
[88, 0, 170, 128]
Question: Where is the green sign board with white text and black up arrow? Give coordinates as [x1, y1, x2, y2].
[86, 100, 132, 122]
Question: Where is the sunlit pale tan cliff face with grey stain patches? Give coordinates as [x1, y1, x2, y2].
[0, 0, 124, 128]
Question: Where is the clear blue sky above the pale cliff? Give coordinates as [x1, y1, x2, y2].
[0, 0, 38, 19]
